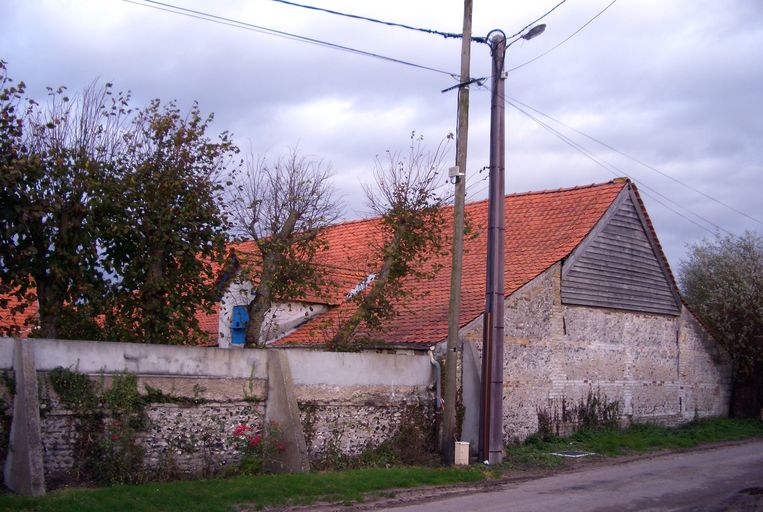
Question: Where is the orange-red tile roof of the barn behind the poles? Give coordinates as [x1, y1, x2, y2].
[268, 180, 627, 346]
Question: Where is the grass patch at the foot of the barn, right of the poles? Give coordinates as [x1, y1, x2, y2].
[506, 418, 763, 468]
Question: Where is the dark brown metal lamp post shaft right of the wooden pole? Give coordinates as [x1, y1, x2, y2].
[482, 31, 506, 464]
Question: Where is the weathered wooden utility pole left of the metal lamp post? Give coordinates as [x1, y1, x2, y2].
[440, 0, 472, 464]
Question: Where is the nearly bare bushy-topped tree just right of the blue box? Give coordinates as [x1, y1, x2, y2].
[232, 148, 342, 347]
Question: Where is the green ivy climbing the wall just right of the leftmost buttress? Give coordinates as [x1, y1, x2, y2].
[41, 367, 266, 485]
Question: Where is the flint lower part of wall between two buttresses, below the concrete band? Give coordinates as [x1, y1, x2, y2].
[38, 372, 264, 486]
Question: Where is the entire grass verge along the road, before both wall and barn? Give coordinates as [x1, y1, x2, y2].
[0, 418, 763, 512]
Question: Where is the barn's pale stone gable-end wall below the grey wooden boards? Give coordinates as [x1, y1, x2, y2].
[462, 264, 731, 442]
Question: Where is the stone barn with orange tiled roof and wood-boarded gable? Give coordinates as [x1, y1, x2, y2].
[215, 179, 730, 446]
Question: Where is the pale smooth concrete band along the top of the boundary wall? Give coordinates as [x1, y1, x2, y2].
[0, 338, 433, 387]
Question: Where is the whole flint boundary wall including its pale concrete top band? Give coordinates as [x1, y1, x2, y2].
[0, 339, 434, 487]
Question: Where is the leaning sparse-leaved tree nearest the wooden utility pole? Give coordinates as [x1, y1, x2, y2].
[328, 132, 452, 350]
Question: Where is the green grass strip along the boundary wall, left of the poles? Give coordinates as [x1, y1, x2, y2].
[0, 467, 485, 512]
